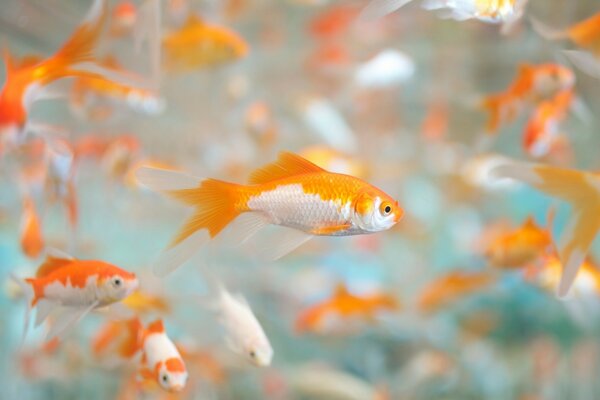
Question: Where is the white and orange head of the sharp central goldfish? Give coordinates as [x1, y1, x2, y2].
[352, 189, 404, 232]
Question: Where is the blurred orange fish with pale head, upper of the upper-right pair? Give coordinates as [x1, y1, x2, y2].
[482, 64, 575, 133]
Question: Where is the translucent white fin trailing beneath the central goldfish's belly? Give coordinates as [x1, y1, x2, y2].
[248, 227, 314, 261]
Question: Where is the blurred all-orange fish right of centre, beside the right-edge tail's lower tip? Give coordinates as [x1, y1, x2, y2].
[485, 217, 552, 268]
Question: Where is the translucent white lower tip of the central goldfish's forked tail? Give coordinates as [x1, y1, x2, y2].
[152, 229, 210, 277]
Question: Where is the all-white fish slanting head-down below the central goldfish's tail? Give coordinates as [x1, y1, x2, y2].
[209, 283, 273, 367]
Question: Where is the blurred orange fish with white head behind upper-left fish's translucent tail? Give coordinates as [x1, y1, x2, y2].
[71, 56, 165, 119]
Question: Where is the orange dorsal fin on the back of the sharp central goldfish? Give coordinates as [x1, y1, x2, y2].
[249, 152, 325, 184]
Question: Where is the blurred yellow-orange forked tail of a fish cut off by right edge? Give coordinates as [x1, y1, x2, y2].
[492, 162, 600, 297]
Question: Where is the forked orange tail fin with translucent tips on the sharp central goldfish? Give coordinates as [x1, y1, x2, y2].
[136, 168, 240, 276]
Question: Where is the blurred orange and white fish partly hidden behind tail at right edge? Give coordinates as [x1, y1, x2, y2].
[525, 254, 600, 297]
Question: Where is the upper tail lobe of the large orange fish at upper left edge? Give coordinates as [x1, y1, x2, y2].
[52, 0, 108, 66]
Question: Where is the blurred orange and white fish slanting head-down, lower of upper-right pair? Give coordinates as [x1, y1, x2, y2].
[523, 90, 573, 157]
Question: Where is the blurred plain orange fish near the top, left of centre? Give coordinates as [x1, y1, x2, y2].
[162, 14, 248, 73]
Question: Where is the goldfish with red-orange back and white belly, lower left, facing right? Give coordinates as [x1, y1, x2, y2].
[13, 250, 138, 338]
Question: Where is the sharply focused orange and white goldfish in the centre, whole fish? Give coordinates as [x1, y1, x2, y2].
[137, 152, 403, 275]
